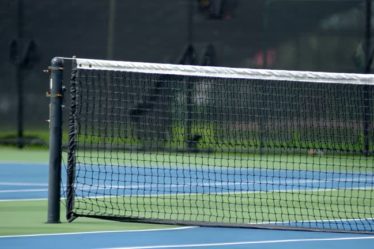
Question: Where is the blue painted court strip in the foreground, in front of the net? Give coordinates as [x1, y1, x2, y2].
[0, 227, 374, 249]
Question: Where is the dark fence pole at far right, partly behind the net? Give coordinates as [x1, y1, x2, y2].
[363, 0, 372, 156]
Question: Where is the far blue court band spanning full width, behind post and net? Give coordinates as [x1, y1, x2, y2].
[0, 163, 374, 200]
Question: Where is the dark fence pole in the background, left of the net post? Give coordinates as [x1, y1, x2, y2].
[16, 0, 24, 148]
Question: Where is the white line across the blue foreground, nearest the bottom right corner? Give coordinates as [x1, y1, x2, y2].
[105, 236, 374, 249]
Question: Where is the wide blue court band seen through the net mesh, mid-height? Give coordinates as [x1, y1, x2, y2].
[72, 165, 374, 196]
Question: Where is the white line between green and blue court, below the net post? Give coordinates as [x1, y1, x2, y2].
[0, 226, 197, 239]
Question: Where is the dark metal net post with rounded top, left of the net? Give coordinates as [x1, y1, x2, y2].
[47, 57, 64, 223]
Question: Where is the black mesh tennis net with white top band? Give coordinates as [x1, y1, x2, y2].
[67, 59, 374, 232]
